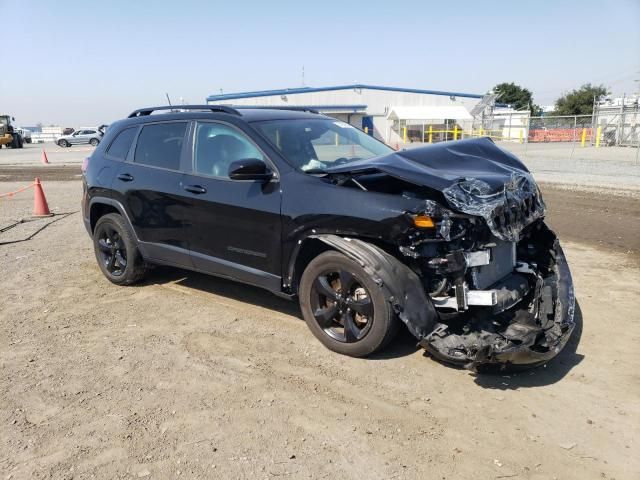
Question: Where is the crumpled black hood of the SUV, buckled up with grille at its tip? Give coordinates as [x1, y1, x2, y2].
[326, 138, 545, 241]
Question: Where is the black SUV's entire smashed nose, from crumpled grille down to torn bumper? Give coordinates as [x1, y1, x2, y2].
[400, 172, 575, 369]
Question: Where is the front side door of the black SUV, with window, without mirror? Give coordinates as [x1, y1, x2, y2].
[184, 121, 282, 291]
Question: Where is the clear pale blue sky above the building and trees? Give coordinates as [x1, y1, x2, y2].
[0, 0, 640, 127]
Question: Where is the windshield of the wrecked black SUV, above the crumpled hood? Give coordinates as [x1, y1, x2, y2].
[253, 118, 394, 173]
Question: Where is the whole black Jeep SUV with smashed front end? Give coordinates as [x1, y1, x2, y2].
[82, 105, 575, 368]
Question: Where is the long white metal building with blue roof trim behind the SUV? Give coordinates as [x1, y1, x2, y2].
[207, 84, 483, 144]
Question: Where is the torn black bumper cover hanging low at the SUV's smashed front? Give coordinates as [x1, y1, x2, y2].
[420, 240, 575, 370]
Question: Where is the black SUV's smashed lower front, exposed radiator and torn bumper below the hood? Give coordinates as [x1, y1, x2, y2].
[420, 220, 575, 369]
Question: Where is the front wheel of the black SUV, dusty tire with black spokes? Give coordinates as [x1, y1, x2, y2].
[298, 251, 398, 357]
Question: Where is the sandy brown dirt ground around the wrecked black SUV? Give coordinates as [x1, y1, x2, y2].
[0, 181, 640, 480]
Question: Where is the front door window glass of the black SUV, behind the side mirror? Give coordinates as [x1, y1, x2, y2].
[194, 122, 265, 178]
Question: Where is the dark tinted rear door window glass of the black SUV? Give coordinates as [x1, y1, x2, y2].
[134, 122, 187, 170]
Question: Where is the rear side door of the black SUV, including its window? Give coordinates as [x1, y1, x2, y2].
[112, 121, 192, 267]
